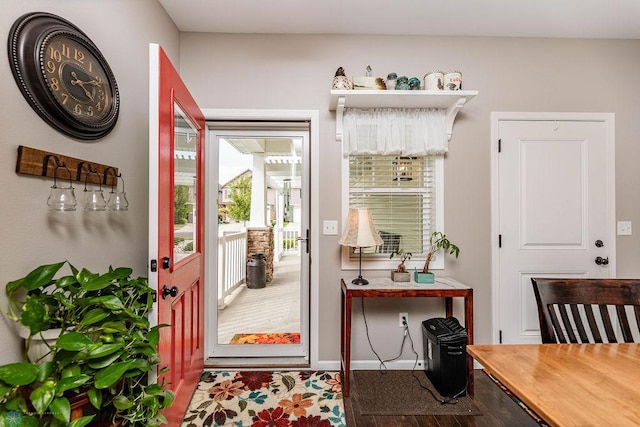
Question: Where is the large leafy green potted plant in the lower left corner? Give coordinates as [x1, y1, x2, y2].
[0, 261, 174, 427]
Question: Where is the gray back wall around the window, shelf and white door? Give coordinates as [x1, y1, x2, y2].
[180, 33, 640, 361]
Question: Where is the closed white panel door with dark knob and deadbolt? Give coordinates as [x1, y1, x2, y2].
[497, 115, 615, 343]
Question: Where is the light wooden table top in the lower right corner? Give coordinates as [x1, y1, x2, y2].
[467, 343, 640, 427]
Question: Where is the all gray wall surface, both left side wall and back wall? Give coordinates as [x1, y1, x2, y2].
[0, 0, 640, 363]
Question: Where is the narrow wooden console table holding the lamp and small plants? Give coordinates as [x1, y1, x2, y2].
[340, 278, 473, 397]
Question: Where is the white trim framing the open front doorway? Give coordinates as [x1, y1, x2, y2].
[202, 108, 320, 369]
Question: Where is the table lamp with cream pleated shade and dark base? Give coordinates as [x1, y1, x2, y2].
[338, 208, 383, 285]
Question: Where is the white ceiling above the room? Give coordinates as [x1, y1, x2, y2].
[159, 0, 640, 39]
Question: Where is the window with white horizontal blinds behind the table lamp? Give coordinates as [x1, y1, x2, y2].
[349, 154, 442, 260]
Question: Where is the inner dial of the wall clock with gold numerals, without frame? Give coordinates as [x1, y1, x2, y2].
[41, 35, 113, 124]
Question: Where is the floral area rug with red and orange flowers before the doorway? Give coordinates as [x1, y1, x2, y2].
[182, 371, 346, 427]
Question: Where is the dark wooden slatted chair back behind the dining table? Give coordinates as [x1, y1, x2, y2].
[531, 278, 640, 344]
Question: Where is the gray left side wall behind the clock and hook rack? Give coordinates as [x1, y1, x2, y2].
[0, 0, 180, 363]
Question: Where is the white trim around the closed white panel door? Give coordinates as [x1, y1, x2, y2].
[490, 111, 616, 344]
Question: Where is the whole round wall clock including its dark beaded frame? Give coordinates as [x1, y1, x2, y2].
[8, 12, 120, 140]
